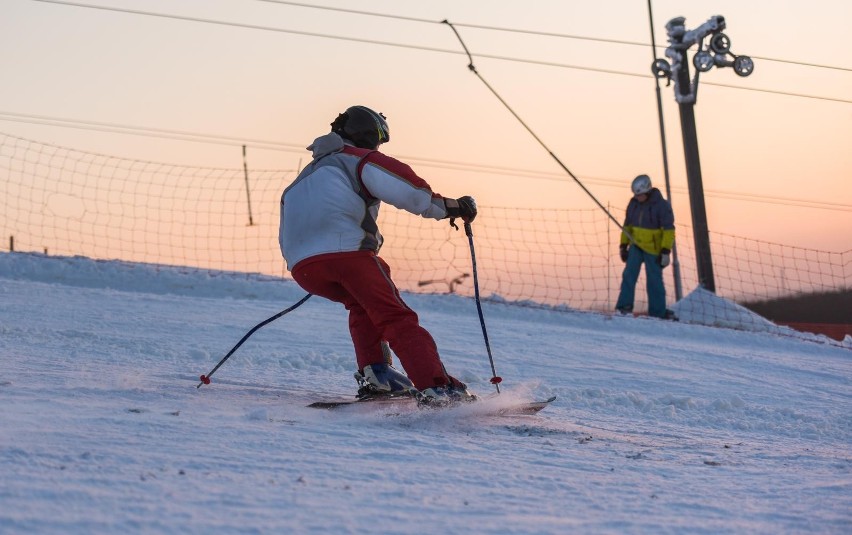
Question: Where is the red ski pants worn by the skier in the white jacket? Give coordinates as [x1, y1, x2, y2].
[291, 251, 457, 390]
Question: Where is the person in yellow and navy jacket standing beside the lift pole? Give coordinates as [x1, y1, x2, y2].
[615, 175, 675, 319]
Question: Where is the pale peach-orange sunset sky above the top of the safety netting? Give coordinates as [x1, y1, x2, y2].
[0, 0, 852, 252]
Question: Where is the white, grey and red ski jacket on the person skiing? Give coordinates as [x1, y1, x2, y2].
[278, 133, 447, 271]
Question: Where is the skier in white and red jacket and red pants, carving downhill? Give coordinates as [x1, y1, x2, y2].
[278, 106, 477, 406]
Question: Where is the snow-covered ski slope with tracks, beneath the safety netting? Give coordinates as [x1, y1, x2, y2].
[0, 253, 852, 534]
